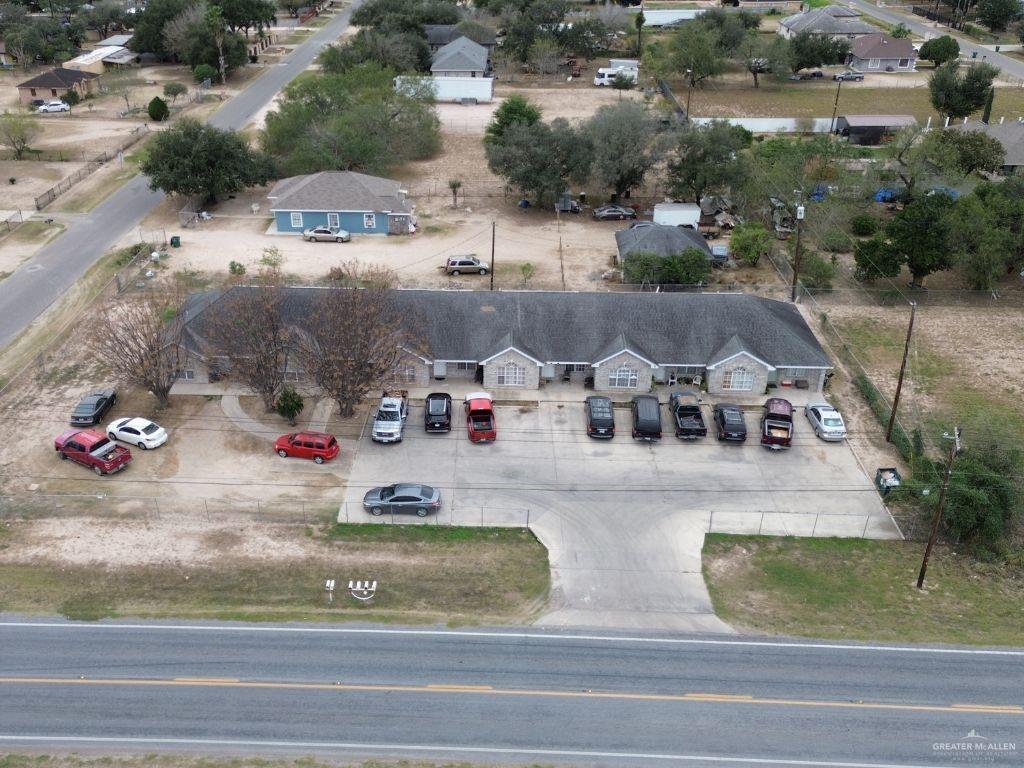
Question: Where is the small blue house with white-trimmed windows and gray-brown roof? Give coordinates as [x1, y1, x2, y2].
[267, 171, 413, 234]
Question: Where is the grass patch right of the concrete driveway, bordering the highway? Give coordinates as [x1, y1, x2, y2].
[703, 535, 1024, 646]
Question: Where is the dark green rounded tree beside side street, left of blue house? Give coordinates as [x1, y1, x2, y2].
[141, 118, 271, 201]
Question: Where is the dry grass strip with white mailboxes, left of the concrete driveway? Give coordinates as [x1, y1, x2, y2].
[0, 517, 549, 624]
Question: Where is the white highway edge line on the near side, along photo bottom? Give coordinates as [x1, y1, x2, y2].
[0, 734, 966, 768]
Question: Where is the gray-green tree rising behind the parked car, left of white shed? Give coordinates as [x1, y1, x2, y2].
[585, 101, 655, 195]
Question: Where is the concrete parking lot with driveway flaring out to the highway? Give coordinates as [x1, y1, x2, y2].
[340, 402, 899, 632]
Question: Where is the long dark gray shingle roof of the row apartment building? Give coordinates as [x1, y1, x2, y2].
[185, 288, 831, 368]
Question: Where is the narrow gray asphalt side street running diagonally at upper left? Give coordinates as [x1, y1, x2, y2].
[0, 0, 361, 348]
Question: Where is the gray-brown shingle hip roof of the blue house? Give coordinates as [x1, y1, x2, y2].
[267, 171, 413, 213]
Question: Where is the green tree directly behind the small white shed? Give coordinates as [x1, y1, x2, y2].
[666, 120, 753, 203]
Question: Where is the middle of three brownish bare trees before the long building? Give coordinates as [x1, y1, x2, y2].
[207, 284, 292, 412]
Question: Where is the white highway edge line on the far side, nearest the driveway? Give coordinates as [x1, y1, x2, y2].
[0, 622, 1024, 657]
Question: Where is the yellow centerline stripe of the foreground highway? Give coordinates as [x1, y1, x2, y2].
[0, 677, 1024, 715]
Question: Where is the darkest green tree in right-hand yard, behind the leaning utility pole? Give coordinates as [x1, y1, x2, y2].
[886, 193, 956, 286]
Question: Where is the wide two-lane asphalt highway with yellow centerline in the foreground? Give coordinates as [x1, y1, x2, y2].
[0, 621, 1024, 766]
